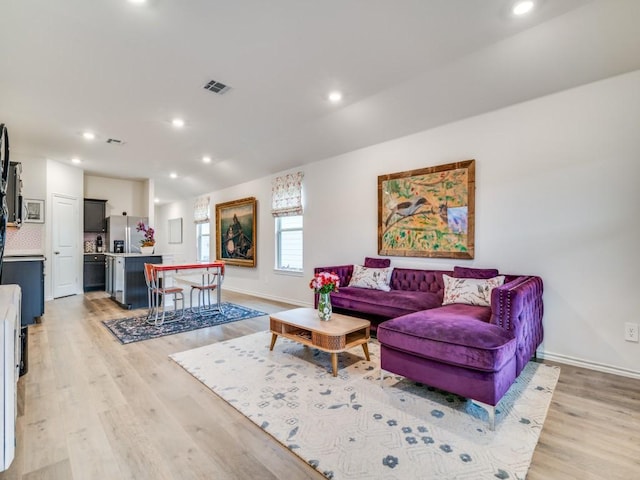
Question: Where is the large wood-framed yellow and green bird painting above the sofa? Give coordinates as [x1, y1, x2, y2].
[378, 160, 475, 258]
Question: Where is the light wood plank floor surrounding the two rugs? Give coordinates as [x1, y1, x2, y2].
[0, 293, 640, 480]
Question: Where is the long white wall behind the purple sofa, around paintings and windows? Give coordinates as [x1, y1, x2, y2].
[162, 71, 640, 376]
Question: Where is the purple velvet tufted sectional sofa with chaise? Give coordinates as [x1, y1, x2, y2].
[315, 258, 543, 422]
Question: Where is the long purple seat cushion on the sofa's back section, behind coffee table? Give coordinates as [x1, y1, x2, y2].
[331, 287, 442, 318]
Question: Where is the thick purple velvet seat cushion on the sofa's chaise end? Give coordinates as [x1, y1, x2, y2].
[377, 304, 516, 372]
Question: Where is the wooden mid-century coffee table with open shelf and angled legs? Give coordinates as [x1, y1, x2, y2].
[269, 308, 371, 377]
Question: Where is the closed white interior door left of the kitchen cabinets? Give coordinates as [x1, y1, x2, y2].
[51, 195, 80, 298]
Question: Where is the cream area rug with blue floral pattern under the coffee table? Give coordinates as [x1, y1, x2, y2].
[171, 332, 560, 480]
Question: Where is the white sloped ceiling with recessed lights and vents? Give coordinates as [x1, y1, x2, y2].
[0, 0, 640, 202]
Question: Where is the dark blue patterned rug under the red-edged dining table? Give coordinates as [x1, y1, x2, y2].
[102, 302, 266, 343]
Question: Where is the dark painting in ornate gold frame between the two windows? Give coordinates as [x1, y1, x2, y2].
[216, 197, 256, 267]
